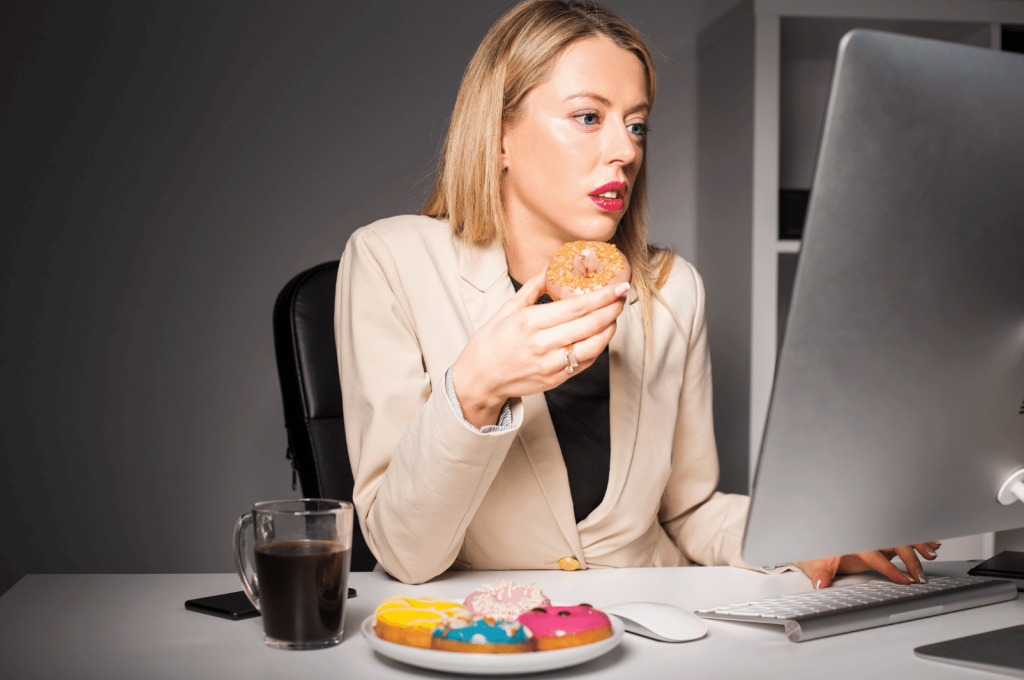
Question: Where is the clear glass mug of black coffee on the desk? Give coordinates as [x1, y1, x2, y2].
[234, 499, 352, 649]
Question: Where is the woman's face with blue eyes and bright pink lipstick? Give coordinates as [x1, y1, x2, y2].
[502, 36, 649, 250]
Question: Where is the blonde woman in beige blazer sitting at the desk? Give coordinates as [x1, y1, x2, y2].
[336, 0, 934, 586]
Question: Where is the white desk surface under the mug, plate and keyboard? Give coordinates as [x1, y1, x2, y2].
[0, 562, 1024, 680]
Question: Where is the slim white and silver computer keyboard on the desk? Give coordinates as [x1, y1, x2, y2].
[696, 577, 1017, 642]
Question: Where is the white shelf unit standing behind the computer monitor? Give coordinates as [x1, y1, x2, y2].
[696, 0, 1024, 512]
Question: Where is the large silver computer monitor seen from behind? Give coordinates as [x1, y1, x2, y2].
[743, 31, 1024, 564]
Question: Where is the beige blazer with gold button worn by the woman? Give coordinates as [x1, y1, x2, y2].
[335, 215, 761, 583]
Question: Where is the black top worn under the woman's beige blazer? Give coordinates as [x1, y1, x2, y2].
[509, 277, 611, 523]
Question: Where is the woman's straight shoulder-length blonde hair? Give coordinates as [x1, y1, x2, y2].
[420, 0, 673, 349]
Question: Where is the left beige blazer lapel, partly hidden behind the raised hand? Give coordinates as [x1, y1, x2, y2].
[456, 236, 585, 567]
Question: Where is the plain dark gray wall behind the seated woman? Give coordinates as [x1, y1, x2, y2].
[0, 0, 730, 592]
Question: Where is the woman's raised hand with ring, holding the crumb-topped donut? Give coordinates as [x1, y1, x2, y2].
[452, 271, 629, 427]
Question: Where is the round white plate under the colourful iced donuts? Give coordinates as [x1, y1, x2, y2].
[362, 615, 626, 675]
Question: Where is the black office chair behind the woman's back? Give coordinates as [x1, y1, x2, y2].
[273, 260, 377, 571]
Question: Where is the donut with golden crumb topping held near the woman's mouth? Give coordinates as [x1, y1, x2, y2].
[547, 241, 631, 300]
